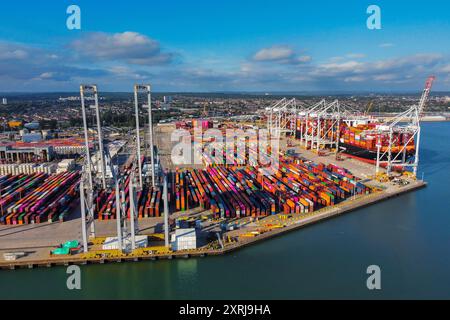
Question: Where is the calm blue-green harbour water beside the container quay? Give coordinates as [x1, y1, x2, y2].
[0, 122, 450, 299]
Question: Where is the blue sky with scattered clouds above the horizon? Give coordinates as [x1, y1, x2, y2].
[0, 0, 450, 92]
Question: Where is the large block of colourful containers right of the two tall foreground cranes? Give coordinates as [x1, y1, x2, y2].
[169, 158, 370, 218]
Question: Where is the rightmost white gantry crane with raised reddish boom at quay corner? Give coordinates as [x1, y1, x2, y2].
[376, 76, 435, 177]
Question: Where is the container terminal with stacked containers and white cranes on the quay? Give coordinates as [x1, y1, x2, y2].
[0, 77, 434, 269]
